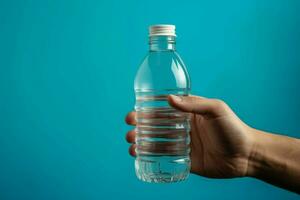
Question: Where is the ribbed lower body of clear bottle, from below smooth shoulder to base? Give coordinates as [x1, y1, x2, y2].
[135, 89, 190, 183]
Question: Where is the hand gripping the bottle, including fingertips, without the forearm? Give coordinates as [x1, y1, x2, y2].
[126, 95, 253, 178]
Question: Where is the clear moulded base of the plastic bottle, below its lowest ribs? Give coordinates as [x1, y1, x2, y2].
[135, 156, 190, 183]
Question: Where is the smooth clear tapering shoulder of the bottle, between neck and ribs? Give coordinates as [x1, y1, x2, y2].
[134, 51, 190, 90]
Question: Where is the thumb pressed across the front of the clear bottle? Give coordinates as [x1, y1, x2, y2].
[168, 95, 228, 117]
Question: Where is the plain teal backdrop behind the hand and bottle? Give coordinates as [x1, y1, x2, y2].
[0, 0, 300, 200]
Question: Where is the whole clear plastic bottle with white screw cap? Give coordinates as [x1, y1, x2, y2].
[134, 25, 191, 183]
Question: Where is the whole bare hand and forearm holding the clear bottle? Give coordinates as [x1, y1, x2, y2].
[126, 95, 300, 194]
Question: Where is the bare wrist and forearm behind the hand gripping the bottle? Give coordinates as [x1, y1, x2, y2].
[248, 129, 300, 194]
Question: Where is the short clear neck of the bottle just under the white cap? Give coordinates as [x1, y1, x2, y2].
[149, 35, 175, 51]
